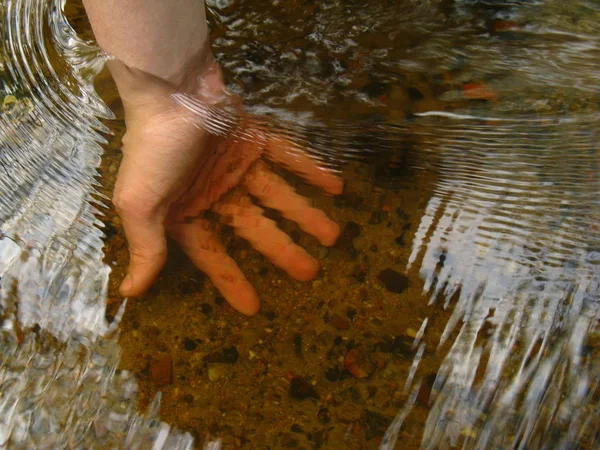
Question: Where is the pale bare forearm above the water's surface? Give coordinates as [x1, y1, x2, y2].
[83, 0, 208, 86]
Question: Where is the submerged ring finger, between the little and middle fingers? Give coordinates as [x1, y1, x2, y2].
[244, 161, 340, 246]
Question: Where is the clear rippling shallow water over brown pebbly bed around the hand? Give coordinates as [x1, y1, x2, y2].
[0, 0, 600, 449]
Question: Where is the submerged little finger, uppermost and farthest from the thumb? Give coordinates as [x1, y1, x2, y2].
[266, 133, 344, 195]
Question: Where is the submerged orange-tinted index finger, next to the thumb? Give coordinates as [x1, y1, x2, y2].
[169, 219, 260, 316]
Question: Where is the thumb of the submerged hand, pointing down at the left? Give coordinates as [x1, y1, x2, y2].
[114, 192, 167, 297]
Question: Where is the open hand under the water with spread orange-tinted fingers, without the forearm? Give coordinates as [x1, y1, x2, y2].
[111, 59, 342, 315]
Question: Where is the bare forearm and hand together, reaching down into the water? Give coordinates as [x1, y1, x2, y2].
[83, 0, 343, 315]
